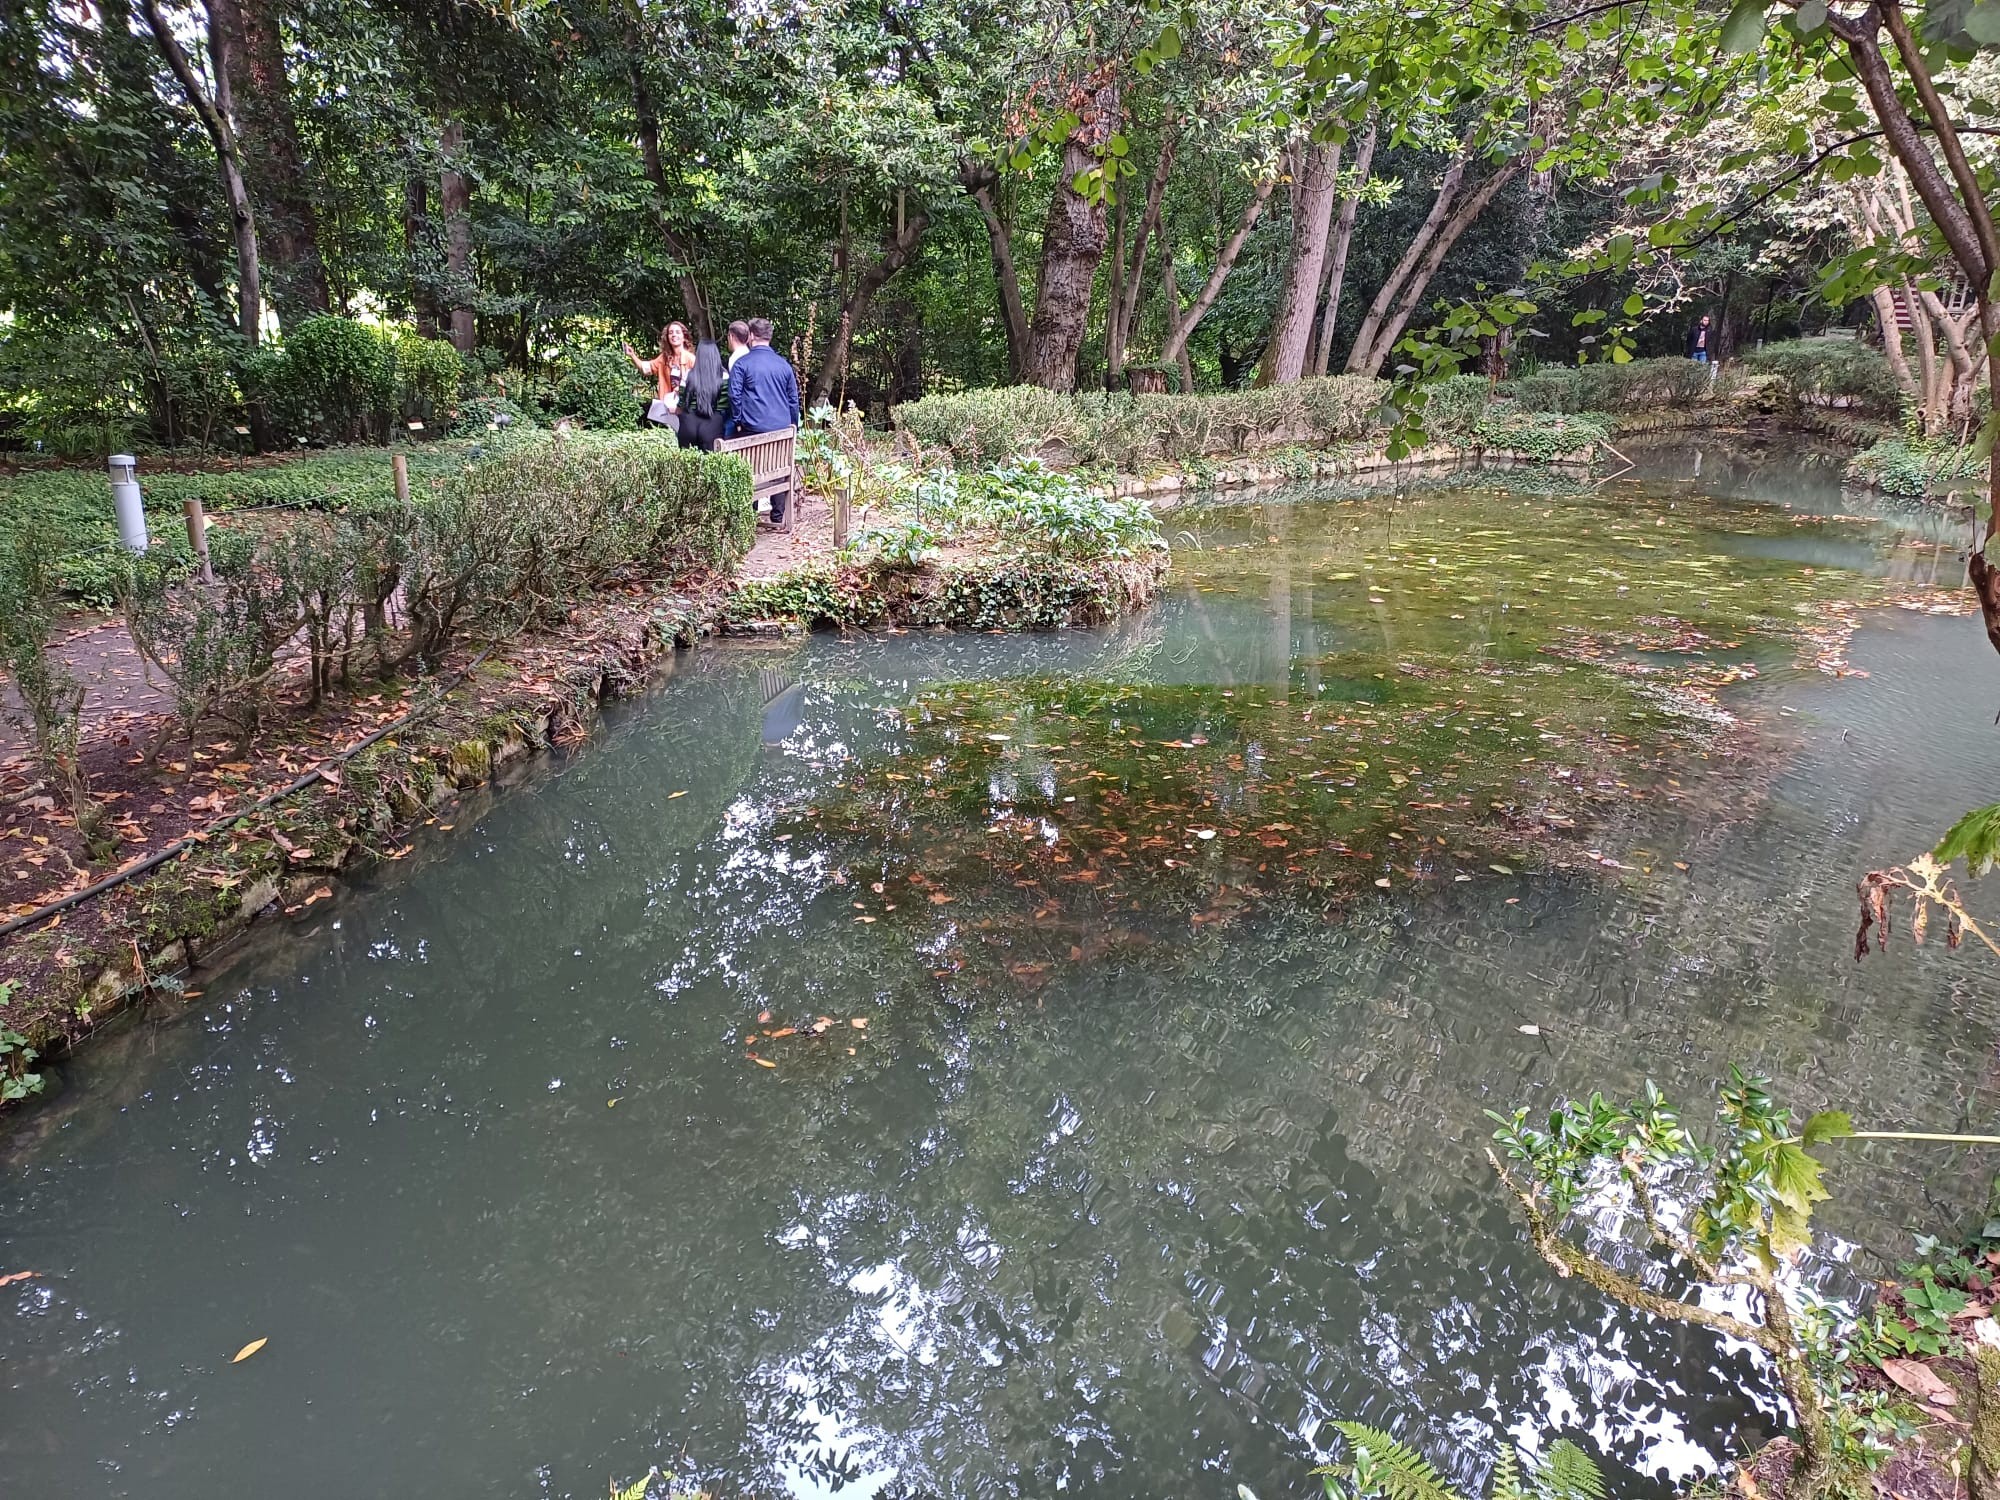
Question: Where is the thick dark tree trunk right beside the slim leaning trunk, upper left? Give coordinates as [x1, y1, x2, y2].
[208, 0, 328, 326]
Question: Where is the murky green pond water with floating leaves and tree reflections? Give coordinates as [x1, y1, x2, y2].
[0, 446, 2000, 1500]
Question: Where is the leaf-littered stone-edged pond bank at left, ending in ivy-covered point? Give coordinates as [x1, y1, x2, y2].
[0, 482, 1168, 1080]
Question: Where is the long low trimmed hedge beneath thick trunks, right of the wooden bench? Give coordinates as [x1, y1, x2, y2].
[892, 376, 1386, 468]
